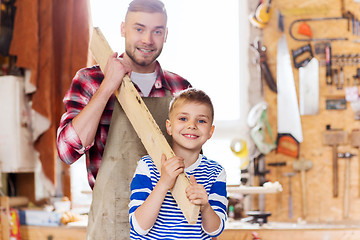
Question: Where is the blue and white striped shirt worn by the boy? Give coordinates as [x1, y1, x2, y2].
[129, 154, 228, 240]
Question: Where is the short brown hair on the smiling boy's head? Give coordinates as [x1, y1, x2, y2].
[169, 88, 214, 121]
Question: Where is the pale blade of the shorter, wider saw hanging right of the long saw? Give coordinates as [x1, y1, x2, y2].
[299, 58, 319, 115]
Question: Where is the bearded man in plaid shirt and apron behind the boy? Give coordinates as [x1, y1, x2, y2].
[57, 0, 190, 239]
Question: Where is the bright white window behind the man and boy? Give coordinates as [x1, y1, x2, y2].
[72, 0, 249, 204]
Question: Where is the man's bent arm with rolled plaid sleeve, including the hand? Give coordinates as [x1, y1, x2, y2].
[57, 54, 130, 164]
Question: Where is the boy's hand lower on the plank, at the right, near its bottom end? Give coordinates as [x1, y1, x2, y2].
[186, 175, 209, 209]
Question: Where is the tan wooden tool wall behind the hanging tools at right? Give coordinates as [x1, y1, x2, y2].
[263, 0, 360, 222]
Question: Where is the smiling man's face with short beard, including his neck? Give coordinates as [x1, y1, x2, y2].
[121, 12, 167, 73]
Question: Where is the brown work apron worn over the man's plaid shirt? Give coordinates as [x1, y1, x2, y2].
[87, 91, 171, 240]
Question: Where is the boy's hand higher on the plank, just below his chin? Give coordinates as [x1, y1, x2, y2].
[158, 154, 185, 190]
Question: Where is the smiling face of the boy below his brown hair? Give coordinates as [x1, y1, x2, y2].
[166, 102, 214, 152]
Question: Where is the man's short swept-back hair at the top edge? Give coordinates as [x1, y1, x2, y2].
[126, 0, 167, 18]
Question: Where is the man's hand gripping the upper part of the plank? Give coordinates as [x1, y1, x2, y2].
[103, 52, 131, 93]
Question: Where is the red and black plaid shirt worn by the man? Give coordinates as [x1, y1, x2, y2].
[57, 62, 191, 188]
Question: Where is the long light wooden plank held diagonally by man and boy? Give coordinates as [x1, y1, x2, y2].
[90, 28, 200, 224]
